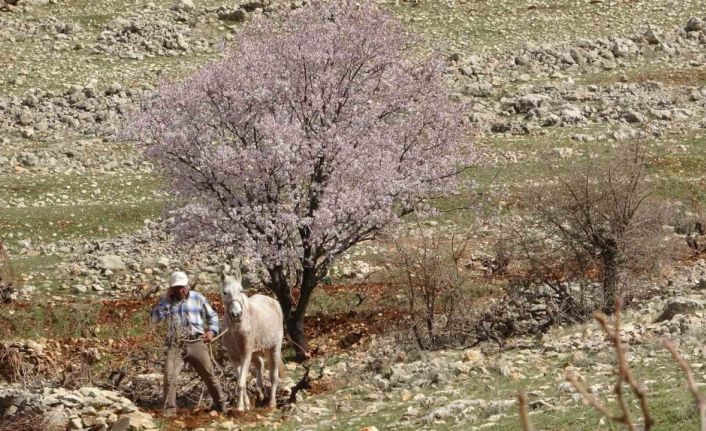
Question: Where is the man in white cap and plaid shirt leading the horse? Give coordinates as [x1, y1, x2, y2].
[150, 271, 226, 416]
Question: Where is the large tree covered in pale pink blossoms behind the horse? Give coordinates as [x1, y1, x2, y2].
[127, 1, 470, 357]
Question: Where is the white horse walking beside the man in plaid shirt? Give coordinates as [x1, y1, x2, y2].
[221, 274, 284, 412]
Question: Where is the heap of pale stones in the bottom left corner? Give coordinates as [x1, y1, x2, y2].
[0, 386, 156, 431]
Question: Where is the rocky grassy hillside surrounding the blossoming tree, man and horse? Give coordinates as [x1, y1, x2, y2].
[0, 0, 706, 430]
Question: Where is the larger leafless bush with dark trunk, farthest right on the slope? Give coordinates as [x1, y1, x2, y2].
[512, 144, 670, 314]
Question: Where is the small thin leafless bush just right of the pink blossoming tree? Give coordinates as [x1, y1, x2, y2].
[391, 221, 470, 350]
